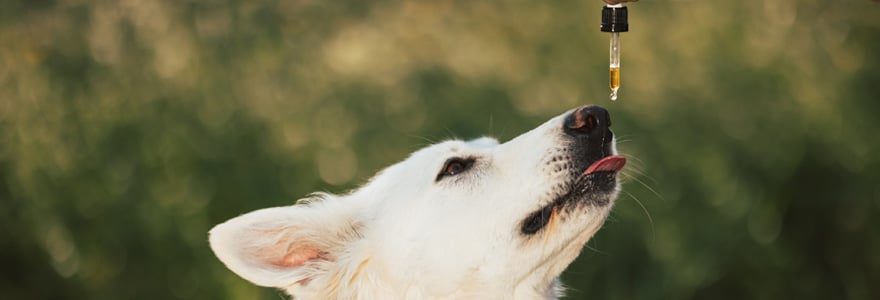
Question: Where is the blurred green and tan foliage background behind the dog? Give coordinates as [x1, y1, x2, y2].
[0, 0, 880, 299]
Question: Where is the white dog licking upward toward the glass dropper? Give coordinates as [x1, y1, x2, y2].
[210, 106, 626, 299]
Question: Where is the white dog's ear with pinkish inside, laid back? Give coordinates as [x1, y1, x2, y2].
[210, 198, 359, 288]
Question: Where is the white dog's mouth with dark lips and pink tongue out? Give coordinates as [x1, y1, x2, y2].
[521, 155, 626, 235]
